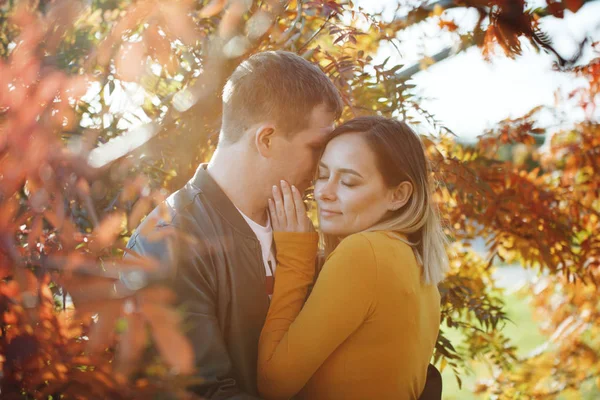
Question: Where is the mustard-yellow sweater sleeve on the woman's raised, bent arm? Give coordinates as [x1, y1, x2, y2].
[258, 234, 377, 399]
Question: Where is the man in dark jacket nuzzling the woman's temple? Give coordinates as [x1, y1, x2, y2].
[128, 51, 342, 399]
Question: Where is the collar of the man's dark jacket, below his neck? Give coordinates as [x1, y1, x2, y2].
[190, 164, 256, 239]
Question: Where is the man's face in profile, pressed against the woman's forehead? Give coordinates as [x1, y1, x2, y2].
[273, 105, 335, 193]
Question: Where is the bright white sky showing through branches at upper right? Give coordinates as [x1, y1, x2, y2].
[355, 0, 600, 141]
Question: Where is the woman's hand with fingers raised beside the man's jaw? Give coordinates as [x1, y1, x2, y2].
[269, 181, 315, 232]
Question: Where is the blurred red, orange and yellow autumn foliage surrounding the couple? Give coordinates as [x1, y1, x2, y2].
[0, 0, 600, 399]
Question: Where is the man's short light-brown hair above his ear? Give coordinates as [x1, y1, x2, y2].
[220, 51, 343, 143]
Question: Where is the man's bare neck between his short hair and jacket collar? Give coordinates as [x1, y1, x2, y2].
[207, 148, 268, 226]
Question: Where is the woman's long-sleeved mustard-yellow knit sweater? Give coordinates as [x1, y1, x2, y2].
[258, 232, 440, 400]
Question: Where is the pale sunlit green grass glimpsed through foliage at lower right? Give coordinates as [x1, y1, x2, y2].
[442, 293, 546, 400]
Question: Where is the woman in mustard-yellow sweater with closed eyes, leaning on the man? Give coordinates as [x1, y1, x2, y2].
[258, 117, 448, 399]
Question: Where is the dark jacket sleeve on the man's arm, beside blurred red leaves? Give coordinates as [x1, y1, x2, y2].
[126, 222, 258, 400]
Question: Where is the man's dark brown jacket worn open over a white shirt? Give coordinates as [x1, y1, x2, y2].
[127, 166, 269, 399]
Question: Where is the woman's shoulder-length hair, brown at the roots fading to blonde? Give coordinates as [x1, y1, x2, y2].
[323, 116, 448, 285]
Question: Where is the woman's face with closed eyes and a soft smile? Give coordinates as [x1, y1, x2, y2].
[315, 133, 399, 236]
